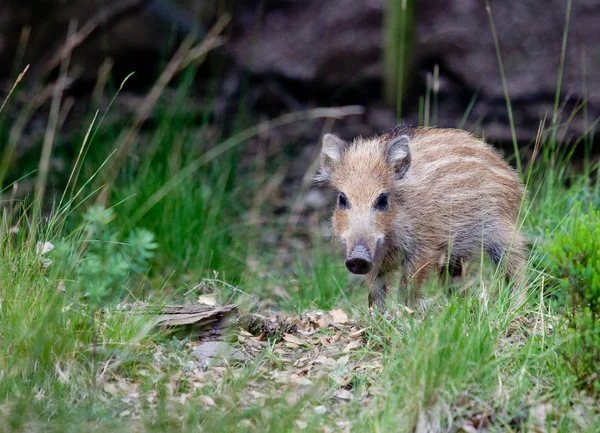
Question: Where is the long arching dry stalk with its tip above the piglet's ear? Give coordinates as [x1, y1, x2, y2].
[129, 105, 364, 225]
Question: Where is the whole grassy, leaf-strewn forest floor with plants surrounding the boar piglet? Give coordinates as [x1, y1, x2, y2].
[0, 33, 600, 433]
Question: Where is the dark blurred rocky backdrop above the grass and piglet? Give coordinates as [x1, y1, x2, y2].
[0, 0, 600, 174]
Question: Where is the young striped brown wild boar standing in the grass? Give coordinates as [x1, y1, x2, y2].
[317, 128, 525, 308]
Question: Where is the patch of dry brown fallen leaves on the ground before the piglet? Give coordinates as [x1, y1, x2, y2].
[99, 308, 382, 431]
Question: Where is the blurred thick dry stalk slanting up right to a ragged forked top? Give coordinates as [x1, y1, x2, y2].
[97, 15, 231, 206]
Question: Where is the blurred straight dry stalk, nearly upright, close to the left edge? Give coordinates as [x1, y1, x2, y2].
[34, 21, 77, 218]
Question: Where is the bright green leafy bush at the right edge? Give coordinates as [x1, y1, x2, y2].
[548, 204, 600, 392]
